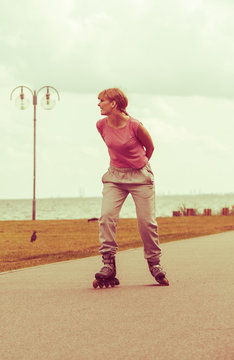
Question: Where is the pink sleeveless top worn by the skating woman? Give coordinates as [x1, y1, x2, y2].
[96, 117, 148, 169]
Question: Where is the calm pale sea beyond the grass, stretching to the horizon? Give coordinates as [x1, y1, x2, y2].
[0, 193, 234, 221]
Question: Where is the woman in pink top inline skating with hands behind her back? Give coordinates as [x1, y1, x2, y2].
[93, 88, 169, 287]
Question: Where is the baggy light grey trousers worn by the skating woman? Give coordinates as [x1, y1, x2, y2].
[99, 163, 161, 264]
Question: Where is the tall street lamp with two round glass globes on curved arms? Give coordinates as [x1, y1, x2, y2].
[10, 86, 60, 220]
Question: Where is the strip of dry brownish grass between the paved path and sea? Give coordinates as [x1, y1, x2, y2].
[0, 216, 234, 272]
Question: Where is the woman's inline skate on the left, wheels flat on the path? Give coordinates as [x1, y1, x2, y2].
[93, 254, 119, 289]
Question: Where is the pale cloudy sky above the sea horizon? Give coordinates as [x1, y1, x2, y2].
[0, 0, 234, 199]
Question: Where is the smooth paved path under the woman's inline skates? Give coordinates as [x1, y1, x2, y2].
[0, 231, 234, 360]
